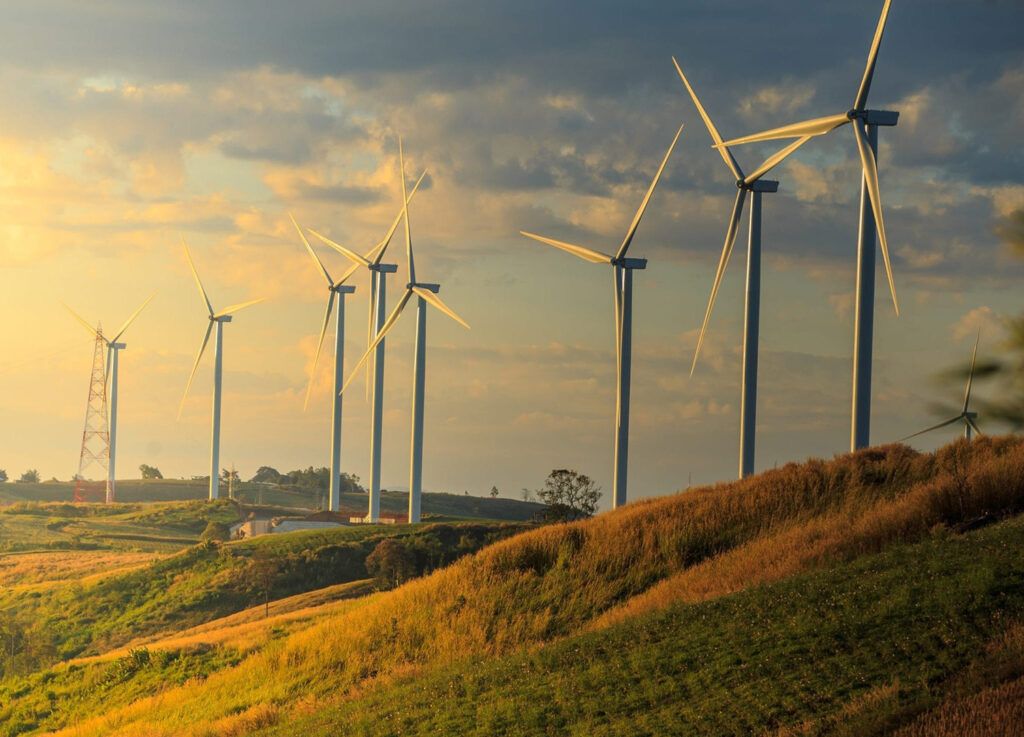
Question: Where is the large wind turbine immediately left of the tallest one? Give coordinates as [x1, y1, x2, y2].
[672, 56, 811, 478]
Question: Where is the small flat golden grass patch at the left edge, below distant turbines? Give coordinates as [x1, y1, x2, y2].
[0, 551, 163, 588]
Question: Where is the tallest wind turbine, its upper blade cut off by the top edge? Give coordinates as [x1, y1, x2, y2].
[718, 0, 899, 450]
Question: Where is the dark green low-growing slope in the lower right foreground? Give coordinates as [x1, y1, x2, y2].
[259, 519, 1024, 737]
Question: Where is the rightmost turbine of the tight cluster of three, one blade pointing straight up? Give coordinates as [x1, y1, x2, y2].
[342, 138, 469, 522]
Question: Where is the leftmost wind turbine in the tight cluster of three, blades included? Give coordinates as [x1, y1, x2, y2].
[289, 215, 359, 512]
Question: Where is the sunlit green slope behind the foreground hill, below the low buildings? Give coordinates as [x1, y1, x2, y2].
[0, 522, 522, 658]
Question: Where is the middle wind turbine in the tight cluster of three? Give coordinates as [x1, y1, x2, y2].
[309, 157, 427, 523]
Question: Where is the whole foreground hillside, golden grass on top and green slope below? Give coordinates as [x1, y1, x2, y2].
[0, 437, 1024, 737]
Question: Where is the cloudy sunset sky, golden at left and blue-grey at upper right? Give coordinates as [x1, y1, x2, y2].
[0, 0, 1024, 505]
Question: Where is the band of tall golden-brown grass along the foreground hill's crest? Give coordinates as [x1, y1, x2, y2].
[44, 438, 1024, 737]
